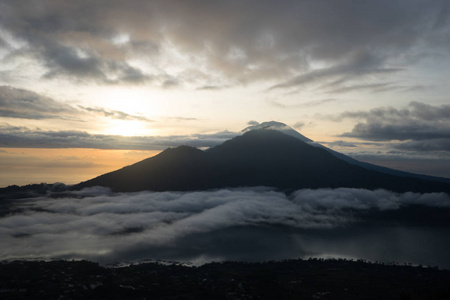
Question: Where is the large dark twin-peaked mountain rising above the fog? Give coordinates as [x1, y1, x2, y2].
[76, 127, 450, 193]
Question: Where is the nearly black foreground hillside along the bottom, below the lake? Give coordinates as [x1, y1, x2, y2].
[0, 259, 450, 300]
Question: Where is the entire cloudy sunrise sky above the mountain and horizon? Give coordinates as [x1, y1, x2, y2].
[0, 0, 450, 186]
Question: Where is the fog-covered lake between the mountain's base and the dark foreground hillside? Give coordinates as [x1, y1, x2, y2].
[0, 187, 450, 268]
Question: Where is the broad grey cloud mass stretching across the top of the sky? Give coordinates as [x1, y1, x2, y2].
[0, 0, 449, 88]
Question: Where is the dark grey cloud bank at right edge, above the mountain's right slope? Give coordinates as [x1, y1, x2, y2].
[335, 102, 450, 151]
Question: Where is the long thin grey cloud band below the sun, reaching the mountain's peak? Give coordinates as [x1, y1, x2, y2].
[0, 122, 238, 150]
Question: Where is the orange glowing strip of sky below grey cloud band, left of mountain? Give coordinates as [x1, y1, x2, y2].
[0, 148, 160, 187]
